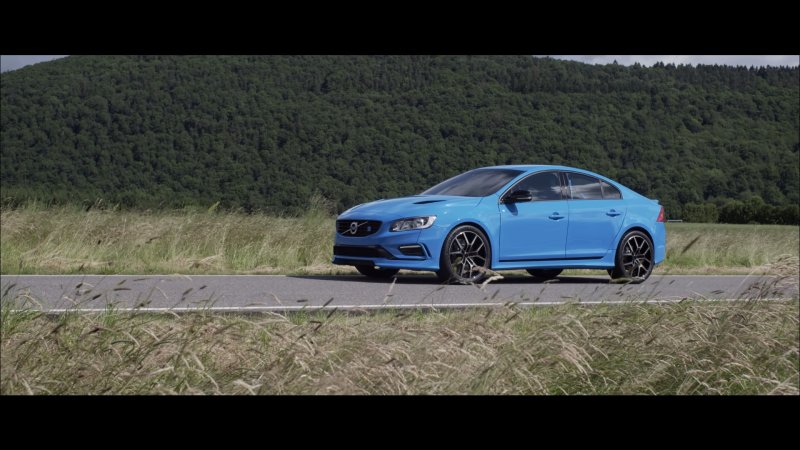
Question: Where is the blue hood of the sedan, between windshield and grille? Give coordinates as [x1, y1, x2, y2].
[339, 195, 482, 220]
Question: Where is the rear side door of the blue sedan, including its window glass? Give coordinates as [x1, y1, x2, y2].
[564, 172, 627, 259]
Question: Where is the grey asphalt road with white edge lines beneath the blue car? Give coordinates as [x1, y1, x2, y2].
[0, 274, 798, 312]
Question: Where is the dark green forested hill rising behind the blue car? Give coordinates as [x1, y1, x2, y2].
[0, 56, 800, 218]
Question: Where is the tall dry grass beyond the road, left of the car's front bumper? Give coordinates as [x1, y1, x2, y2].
[0, 200, 347, 274]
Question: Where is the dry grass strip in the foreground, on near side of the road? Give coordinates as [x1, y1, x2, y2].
[0, 298, 800, 395]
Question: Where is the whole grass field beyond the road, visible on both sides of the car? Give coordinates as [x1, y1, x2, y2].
[0, 205, 800, 274]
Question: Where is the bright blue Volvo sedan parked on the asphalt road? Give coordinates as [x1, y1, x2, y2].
[333, 165, 666, 284]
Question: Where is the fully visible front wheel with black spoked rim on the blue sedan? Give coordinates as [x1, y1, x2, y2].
[436, 225, 492, 284]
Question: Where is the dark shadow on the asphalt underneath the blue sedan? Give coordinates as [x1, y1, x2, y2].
[287, 274, 611, 286]
